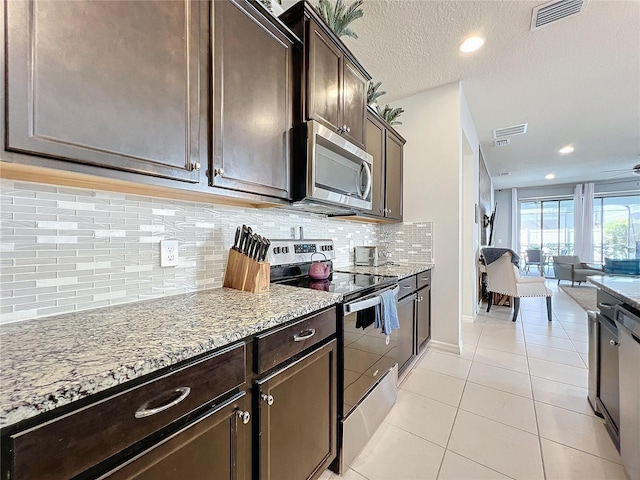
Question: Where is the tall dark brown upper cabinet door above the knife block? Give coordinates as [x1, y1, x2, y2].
[215, 0, 294, 200]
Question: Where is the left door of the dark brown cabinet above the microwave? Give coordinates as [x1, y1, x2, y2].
[307, 21, 342, 132]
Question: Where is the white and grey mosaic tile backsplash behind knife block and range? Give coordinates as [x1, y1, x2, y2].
[0, 179, 379, 323]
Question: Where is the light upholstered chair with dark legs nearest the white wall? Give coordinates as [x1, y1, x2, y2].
[481, 248, 553, 322]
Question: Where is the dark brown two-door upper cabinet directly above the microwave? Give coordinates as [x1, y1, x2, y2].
[279, 2, 371, 147]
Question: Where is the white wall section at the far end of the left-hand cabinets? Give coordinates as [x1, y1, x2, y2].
[393, 83, 478, 350]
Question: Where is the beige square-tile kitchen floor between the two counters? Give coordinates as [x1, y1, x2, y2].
[321, 280, 626, 480]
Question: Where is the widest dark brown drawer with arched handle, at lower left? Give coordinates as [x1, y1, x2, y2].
[11, 344, 246, 480]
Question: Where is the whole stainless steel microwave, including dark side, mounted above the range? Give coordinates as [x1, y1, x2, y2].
[293, 121, 374, 212]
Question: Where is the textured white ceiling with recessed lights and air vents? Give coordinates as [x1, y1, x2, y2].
[330, 0, 640, 188]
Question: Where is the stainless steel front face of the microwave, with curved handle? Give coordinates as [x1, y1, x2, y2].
[307, 121, 373, 210]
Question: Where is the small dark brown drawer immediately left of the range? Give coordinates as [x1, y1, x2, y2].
[256, 307, 336, 373]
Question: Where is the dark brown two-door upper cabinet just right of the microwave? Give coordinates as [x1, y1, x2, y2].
[365, 109, 405, 221]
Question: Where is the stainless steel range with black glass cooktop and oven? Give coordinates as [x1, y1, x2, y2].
[268, 239, 399, 473]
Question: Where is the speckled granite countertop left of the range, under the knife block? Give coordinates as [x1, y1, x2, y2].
[0, 284, 342, 427]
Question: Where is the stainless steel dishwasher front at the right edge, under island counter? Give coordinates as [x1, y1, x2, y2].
[615, 305, 640, 479]
